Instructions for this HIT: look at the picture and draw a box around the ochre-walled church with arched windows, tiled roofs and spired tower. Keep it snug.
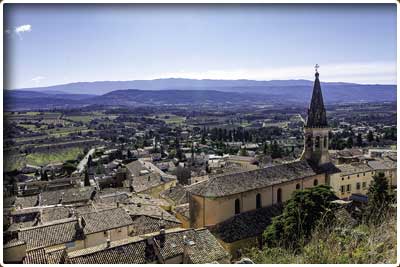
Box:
[188,65,339,256]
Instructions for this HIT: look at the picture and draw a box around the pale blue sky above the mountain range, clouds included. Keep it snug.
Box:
[4,4,397,89]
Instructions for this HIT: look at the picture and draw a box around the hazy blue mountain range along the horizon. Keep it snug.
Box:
[4,78,396,110]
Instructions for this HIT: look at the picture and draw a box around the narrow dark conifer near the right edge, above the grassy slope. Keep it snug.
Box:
[366,172,390,224]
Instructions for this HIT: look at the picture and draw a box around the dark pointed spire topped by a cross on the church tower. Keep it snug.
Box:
[306,64,328,128]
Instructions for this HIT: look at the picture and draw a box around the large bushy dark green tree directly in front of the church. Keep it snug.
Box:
[263,185,336,248]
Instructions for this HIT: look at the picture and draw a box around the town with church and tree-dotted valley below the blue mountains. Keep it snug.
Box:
[3,72,397,264]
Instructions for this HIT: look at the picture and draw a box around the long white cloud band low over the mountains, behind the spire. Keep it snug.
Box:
[152,62,397,84]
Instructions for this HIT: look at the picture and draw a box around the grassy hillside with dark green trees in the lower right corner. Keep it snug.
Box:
[246,174,397,264]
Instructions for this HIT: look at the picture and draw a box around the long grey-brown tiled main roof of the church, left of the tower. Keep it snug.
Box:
[190,160,317,197]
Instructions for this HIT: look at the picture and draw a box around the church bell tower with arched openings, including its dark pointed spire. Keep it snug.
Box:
[301,64,330,165]
